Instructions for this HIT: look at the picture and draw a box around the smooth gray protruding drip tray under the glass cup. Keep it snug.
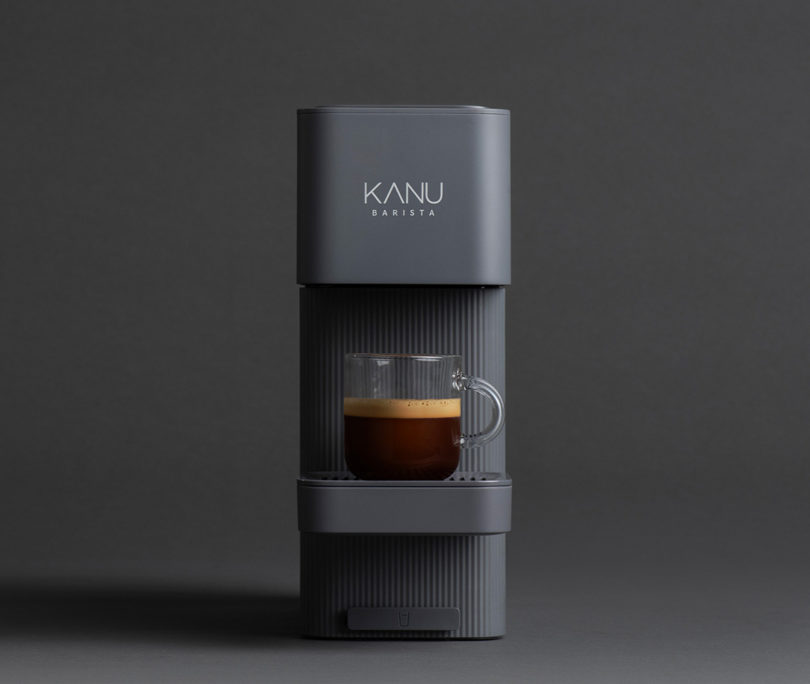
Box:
[298,472,512,534]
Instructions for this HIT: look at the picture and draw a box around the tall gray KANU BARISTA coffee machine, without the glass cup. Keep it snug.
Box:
[298,106,512,639]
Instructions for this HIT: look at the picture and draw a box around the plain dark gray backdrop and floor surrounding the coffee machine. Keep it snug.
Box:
[0,1,810,682]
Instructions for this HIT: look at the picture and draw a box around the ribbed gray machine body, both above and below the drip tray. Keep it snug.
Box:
[300,286,506,639]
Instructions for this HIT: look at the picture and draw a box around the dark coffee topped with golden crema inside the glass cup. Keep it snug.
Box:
[343,397,461,480]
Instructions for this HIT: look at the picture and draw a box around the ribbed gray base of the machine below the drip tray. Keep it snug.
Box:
[301,533,506,639]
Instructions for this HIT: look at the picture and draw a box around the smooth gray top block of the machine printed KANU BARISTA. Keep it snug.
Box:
[298,106,511,285]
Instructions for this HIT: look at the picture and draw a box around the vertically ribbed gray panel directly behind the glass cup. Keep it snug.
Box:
[300,287,506,473]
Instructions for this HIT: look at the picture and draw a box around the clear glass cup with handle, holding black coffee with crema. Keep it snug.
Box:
[343,354,504,480]
